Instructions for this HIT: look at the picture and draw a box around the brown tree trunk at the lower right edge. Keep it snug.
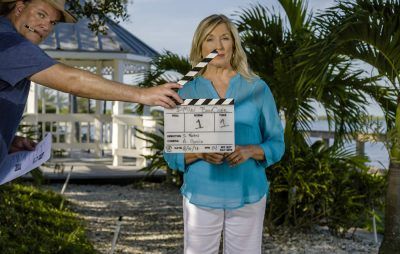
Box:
[379,161,400,254]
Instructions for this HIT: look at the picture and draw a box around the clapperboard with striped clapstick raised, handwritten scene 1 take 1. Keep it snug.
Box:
[164,50,235,153]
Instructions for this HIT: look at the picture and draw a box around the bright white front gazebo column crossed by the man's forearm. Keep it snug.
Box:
[112,60,124,166]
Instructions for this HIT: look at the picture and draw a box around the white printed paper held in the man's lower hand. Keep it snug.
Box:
[0,133,51,185]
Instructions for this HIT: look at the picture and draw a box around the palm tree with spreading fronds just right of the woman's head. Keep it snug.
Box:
[135,1,391,228]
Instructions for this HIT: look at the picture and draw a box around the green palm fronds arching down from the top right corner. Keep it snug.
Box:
[307,0,400,133]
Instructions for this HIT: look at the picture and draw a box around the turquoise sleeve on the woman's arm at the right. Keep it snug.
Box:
[255,80,285,167]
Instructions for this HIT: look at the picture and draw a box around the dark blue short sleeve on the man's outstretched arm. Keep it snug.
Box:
[0,33,57,86]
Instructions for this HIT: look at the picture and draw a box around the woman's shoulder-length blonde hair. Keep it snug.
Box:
[189,14,257,80]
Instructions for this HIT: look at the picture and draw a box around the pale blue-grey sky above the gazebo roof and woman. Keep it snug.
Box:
[120,0,382,116]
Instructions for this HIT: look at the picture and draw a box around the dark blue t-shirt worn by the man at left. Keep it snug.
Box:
[0,16,57,167]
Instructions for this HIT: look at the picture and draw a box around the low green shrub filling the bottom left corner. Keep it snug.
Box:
[0,184,95,254]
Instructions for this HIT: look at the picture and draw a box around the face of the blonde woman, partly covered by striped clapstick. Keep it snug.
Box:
[201,23,234,68]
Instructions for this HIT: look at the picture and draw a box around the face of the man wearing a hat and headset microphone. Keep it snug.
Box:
[12,0,61,44]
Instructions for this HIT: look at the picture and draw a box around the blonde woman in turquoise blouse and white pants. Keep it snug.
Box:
[164,15,284,254]
